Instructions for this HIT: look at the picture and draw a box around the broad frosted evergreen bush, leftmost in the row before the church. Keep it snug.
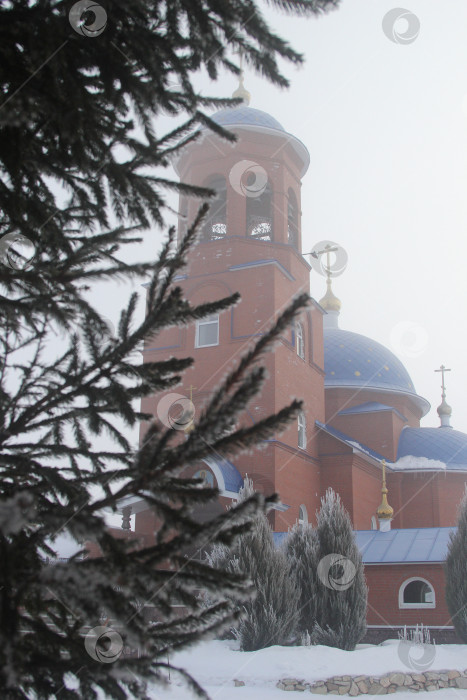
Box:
[208,479,300,651]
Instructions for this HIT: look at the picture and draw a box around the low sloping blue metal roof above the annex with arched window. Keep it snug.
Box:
[274,527,457,564]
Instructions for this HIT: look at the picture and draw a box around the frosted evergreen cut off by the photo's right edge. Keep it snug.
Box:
[444,490,467,644]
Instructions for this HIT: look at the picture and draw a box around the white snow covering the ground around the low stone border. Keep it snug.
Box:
[144,640,467,700]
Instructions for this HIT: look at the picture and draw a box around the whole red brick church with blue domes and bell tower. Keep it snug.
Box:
[117,80,467,642]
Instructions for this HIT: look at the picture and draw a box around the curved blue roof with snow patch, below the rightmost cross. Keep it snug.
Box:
[397,427,467,469]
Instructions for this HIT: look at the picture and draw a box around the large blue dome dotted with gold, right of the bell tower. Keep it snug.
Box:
[324,328,419,399]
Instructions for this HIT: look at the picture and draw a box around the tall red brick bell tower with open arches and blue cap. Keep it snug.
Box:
[143,85,324,531]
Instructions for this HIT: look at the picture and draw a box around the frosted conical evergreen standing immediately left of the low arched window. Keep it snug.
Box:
[312,489,367,650]
